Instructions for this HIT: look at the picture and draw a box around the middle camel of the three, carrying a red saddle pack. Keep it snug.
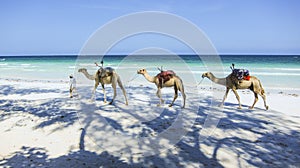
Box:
[137,69,186,108]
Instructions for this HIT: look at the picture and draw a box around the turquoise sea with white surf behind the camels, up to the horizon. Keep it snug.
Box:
[0,55,300,90]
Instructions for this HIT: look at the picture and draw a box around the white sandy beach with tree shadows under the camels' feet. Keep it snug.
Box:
[0,79,300,167]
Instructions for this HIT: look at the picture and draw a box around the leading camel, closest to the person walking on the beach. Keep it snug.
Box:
[78,67,128,105]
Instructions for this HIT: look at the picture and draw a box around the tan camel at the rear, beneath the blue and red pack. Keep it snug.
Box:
[202,72,269,110]
